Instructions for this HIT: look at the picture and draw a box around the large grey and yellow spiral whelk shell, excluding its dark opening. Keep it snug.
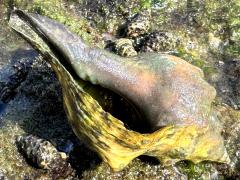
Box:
[10,11,229,170]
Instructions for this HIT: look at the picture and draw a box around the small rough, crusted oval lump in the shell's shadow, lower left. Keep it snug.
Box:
[16,135,72,178]
